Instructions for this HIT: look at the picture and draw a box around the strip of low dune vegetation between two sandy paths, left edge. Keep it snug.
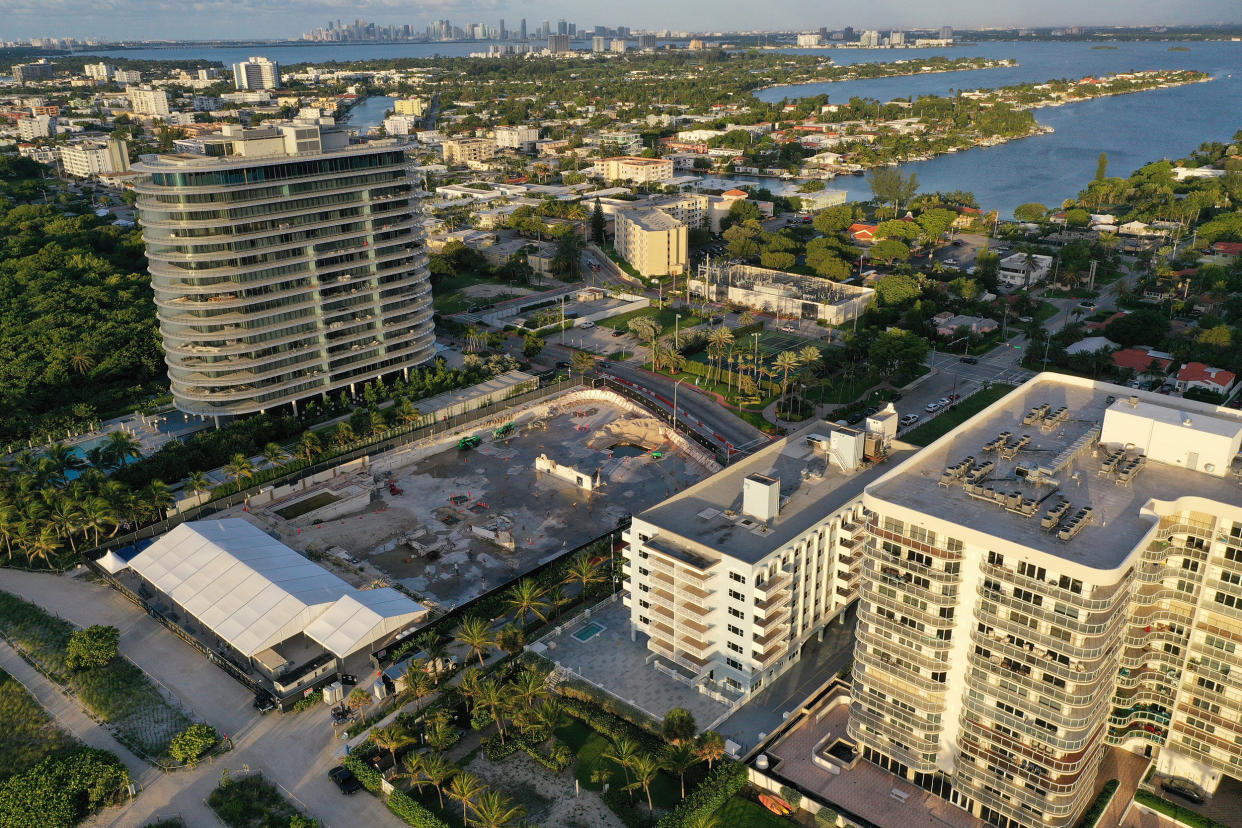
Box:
[0,591,191,765]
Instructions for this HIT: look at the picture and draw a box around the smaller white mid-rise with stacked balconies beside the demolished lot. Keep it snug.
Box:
[623,417,910,698]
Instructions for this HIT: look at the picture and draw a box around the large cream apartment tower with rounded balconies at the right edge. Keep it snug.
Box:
[850,374,1242,828]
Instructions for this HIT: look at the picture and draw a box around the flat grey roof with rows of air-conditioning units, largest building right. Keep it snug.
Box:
[867,374,1242,570]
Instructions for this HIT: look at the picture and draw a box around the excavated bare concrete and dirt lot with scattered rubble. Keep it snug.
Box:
[275,397,707,607]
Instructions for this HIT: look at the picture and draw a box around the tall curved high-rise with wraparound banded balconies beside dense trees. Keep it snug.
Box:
[134,122,435,418]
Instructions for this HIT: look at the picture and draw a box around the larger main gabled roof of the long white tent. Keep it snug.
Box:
[129,518,354,657]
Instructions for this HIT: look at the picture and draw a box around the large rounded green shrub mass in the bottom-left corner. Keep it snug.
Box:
[0,747,129,828]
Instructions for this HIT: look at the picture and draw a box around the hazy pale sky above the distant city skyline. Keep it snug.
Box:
[9,0,1242,40]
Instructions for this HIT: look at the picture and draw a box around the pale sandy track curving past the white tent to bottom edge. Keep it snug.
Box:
[0,570,405,828]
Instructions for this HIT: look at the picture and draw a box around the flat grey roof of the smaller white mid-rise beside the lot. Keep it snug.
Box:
[637,421,917,564]
